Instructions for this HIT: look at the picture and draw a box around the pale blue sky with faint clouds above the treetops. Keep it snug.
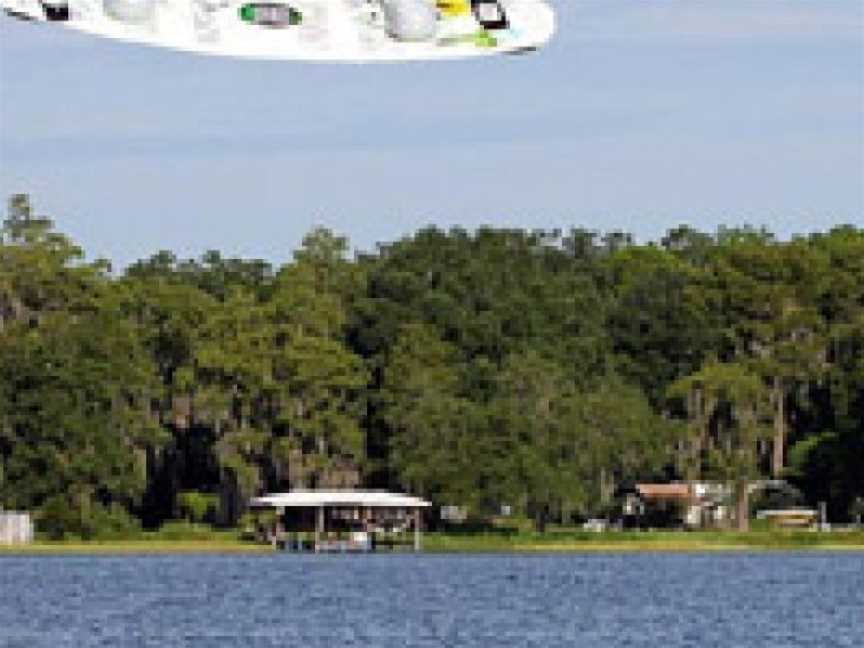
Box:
[0,0,864,267]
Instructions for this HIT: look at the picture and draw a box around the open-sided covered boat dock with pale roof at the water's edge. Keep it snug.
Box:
[249,490,431,553]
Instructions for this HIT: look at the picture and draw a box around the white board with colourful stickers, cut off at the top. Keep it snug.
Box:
[0,0,555,62]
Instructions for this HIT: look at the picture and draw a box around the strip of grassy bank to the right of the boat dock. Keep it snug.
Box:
[424,531,864,552]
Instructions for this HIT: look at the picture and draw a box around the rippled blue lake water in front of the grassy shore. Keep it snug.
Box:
[0,553,864,648]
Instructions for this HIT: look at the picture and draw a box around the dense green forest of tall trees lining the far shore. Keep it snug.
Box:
[0,195,864,537]
